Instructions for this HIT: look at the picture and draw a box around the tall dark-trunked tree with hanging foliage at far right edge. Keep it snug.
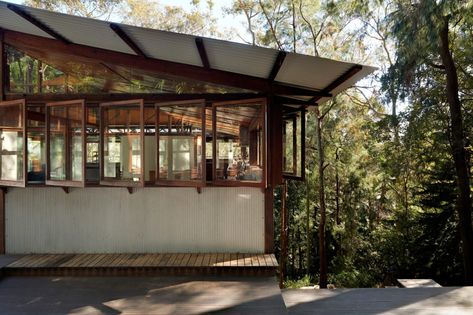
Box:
[392,0,473,284]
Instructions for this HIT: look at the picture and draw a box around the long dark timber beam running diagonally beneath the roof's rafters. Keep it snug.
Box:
[5,30,331,97]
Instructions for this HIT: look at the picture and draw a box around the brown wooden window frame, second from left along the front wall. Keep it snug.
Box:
[45,99,87,187]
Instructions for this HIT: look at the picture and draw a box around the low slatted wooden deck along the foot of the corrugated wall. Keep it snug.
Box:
[4,253,278,275]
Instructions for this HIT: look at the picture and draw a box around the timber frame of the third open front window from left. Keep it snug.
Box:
[99,99,145,187]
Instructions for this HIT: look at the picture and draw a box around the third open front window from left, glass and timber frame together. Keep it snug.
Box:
[100,100,144,187]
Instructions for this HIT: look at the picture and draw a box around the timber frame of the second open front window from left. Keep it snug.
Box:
[45,99,87,188]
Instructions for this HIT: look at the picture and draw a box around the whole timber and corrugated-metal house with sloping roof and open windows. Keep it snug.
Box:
[0,2,373,266]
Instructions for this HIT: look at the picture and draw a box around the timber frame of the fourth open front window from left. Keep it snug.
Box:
[155,99,206,187]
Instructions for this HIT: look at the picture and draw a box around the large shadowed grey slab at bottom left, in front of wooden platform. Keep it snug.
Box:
[0,276,286,315]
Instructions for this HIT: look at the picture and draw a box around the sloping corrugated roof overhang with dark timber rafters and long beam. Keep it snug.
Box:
[0,1,375,104]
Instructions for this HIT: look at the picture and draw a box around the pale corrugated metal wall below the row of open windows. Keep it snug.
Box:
[6,187,264,254]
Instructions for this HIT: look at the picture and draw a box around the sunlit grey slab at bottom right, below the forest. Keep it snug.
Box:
[282,287,473,315]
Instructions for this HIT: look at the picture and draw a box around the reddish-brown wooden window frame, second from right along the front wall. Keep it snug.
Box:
[155,99,207,187]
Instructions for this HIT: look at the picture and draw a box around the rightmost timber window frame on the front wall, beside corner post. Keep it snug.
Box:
[212,98,268,188]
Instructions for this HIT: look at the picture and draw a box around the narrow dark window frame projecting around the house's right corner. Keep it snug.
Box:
[281,107,306,181]
